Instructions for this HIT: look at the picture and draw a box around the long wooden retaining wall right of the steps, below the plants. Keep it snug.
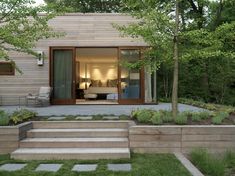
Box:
[129,125,235,153]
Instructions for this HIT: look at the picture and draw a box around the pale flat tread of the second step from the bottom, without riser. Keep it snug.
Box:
[20,138,128,142]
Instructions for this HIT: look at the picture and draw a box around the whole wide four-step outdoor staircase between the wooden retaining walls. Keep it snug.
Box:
[11,121,131,160]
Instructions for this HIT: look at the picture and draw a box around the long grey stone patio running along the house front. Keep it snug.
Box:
[0,103,206,116]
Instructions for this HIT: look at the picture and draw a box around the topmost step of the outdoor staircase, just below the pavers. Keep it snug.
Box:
[32,120,130,129]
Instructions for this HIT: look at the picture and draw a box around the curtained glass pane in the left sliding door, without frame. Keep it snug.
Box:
[53,50,73,99]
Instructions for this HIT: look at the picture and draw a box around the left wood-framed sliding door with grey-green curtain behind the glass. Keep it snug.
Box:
[51,48,75,104]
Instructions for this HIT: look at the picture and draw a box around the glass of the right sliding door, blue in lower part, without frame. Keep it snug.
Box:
[120,50,141,99]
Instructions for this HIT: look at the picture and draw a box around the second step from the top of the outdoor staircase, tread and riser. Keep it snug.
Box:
[27,128,128,138]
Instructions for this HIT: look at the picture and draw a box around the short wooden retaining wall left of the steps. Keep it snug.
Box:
[0,122,32,154]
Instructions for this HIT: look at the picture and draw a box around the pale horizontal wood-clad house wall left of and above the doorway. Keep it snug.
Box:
[0,13,146,105]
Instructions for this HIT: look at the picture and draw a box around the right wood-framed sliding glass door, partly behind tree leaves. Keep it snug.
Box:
[119,49,144,104]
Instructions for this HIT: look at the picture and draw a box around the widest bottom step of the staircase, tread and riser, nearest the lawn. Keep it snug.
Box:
[11,148,130,160]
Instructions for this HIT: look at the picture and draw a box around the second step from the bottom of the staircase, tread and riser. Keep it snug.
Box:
[20,138,129,148]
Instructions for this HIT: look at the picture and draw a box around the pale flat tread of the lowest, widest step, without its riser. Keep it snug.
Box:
[12,148,130,155]
